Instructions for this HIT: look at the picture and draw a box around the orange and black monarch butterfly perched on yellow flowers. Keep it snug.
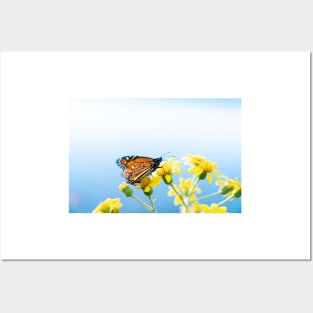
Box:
[116,155,162,185]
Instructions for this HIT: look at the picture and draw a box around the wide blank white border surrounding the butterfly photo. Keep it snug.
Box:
[1,52,311,260]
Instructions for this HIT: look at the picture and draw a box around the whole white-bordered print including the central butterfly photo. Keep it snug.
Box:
[1,52,311,260]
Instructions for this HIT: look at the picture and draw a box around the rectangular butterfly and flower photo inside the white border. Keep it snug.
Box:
[69,98,241,213]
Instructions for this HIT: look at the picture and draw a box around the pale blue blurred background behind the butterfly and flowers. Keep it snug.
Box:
[69,99,241,213]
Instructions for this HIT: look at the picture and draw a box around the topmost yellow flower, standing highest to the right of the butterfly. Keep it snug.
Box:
[184,154,217,183]
